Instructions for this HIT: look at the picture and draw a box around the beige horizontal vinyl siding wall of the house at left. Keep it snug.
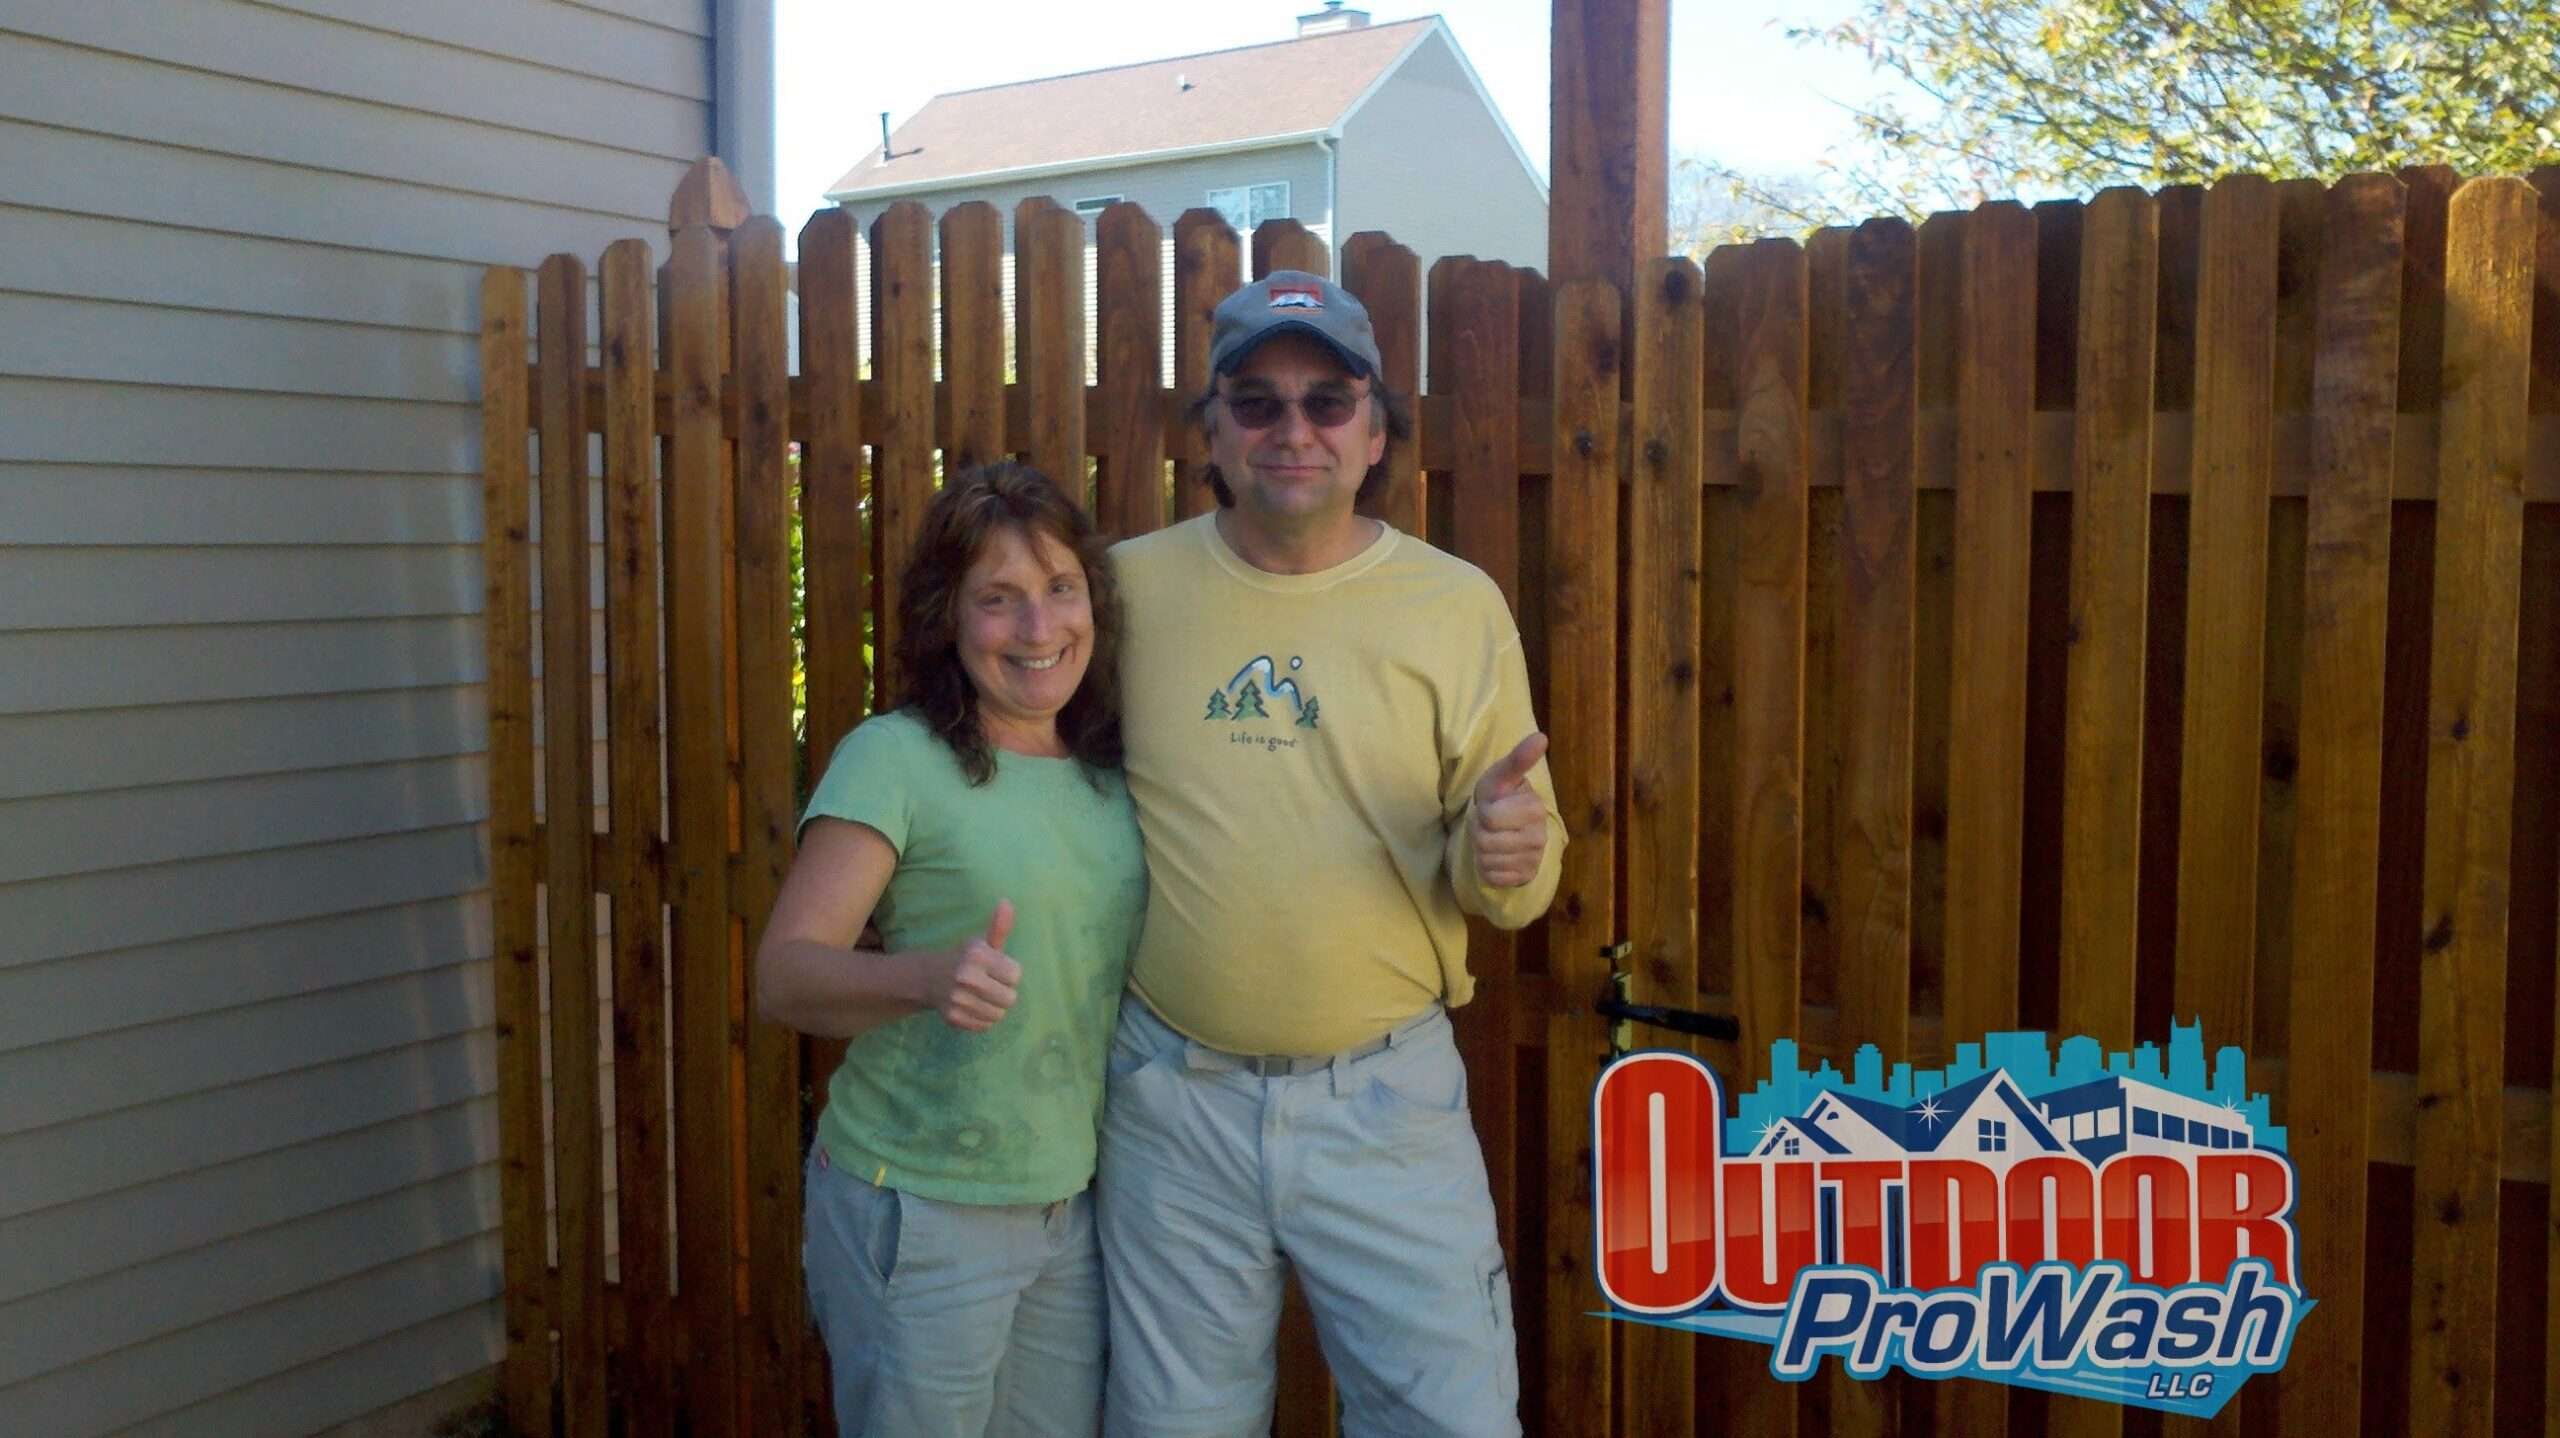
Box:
[0,0,712,1438]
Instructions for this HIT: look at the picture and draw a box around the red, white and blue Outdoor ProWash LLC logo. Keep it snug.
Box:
[1592,1026,2312,1418]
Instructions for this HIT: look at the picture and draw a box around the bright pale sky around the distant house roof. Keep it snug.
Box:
[776,0,1882,228]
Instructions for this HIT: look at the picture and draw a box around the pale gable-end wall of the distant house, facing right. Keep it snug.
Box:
[1336,28,1546,271]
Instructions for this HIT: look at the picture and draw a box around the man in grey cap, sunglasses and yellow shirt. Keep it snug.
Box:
[1098,271,1564,1438]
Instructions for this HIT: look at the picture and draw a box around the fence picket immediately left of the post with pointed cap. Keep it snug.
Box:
[596,241,676,1438]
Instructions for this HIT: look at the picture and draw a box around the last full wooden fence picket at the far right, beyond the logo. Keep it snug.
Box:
[2409,179,2540,1435]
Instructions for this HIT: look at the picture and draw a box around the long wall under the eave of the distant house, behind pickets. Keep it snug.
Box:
[845,141,1334,381]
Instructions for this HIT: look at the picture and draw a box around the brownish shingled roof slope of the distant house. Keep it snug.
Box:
[827,15,1439,200]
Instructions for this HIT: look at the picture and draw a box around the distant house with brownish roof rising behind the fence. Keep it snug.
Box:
[827,0,1546,363]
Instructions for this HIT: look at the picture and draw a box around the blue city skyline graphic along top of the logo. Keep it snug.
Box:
[1725,1021,2286,1157]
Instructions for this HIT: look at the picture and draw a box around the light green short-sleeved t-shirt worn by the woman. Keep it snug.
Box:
[801,711,1147,1203]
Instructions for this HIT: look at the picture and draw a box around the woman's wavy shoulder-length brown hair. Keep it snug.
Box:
[899,461,1121,786]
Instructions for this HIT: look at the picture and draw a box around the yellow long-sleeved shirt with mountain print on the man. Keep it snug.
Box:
[1111,514,1564,1054]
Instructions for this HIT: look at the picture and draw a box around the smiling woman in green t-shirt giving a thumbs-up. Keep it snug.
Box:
[755,463,1147,1438]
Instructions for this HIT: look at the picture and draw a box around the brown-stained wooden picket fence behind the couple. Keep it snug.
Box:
[481,169,2560,1438]
